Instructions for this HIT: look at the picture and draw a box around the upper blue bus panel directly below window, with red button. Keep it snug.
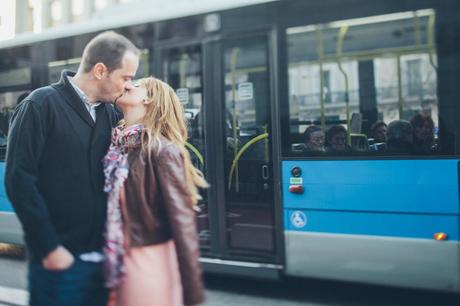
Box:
[282,160,459,214]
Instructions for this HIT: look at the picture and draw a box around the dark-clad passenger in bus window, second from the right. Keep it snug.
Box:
[387,120,413,154]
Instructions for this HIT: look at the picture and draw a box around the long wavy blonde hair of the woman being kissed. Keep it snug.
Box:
[139,77,208,206]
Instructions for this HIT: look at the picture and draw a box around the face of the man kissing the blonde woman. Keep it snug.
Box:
[99,51,139,102]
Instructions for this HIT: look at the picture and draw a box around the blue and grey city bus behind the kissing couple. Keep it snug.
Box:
[0,0,460,292]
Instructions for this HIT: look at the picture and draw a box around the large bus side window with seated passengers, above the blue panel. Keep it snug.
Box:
[283,10,453,156]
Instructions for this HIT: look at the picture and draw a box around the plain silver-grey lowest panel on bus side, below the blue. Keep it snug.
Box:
[285,231,460,292]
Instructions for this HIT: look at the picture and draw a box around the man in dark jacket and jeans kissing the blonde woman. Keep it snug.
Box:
[5,32,139,306]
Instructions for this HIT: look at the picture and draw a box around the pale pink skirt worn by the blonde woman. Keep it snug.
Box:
[109,240,183,306]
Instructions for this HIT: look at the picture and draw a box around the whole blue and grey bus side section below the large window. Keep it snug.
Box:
[282,160,460,291]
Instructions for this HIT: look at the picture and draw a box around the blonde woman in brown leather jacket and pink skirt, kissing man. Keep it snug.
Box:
[104,77,207,306]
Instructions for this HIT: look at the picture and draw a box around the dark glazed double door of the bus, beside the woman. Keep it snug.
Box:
[161,36,277,276]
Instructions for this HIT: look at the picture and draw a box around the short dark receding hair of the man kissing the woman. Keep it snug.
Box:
[80,31,140,73]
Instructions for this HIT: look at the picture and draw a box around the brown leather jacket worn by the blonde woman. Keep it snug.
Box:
[121,138,204,305]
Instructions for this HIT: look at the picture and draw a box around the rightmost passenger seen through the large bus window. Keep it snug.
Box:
[410,113,438,154]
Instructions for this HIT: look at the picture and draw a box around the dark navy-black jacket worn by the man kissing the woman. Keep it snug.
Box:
[5,71,119,260]
